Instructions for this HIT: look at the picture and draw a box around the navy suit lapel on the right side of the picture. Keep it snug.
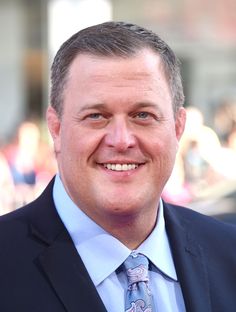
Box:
[164,204,211,312]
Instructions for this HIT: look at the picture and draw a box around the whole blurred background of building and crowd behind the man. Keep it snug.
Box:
[0,0,236,222]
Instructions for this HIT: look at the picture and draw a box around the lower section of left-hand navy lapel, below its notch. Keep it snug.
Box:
[39,231,106,312]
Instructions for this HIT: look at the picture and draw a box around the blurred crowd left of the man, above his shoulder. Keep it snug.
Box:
[0,121,56,214]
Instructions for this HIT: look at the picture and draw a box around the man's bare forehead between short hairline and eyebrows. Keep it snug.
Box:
[64,49,171,111]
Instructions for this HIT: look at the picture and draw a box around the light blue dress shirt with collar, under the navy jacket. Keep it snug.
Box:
[53,175,185,312]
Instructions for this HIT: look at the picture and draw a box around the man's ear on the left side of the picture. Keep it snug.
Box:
[46,106,61,155]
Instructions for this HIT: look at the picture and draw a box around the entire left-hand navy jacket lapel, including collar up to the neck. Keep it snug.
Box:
[27,181,106,312]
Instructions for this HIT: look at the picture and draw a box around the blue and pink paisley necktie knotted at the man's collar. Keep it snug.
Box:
[123,252,154,312]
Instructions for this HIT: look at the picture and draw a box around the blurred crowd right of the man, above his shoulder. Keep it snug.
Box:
[163,102,236,204]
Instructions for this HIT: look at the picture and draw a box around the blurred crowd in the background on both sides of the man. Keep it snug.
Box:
[0,103,236,214]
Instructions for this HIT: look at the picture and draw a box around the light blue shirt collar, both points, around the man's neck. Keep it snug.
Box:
[53,175,177,286]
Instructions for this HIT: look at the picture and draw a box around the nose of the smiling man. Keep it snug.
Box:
[105,118,136,152]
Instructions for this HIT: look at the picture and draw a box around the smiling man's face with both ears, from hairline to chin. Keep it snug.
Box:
[48,50,185,225]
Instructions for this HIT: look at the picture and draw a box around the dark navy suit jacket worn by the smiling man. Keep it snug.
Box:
[0,181,236,312]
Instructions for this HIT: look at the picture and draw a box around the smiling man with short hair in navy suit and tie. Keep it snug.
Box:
[0,22,236,312]
